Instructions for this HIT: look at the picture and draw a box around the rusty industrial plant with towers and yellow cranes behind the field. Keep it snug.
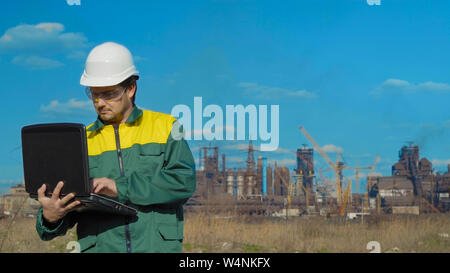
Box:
[185,127,450,218]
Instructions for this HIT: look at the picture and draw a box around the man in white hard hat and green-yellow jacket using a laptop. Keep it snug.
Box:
[36,42,196,252]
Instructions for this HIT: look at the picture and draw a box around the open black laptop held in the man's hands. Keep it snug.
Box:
[22,123,137,216]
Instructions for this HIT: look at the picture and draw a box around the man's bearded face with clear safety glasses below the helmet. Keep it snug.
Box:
[91,85,136,124]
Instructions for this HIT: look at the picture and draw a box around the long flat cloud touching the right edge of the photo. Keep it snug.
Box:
[371,79,450,96]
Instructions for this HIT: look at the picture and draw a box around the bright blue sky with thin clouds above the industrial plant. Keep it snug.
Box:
[0,0,450,192]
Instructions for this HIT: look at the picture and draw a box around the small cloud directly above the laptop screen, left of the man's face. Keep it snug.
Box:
[40,99,95,117]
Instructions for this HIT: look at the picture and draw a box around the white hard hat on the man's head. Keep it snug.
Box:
[80,42,139,86]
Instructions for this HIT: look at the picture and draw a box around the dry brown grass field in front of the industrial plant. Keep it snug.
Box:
[0,214,450,253]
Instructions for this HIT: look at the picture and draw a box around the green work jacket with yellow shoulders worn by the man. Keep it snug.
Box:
[36,106,196,252]
